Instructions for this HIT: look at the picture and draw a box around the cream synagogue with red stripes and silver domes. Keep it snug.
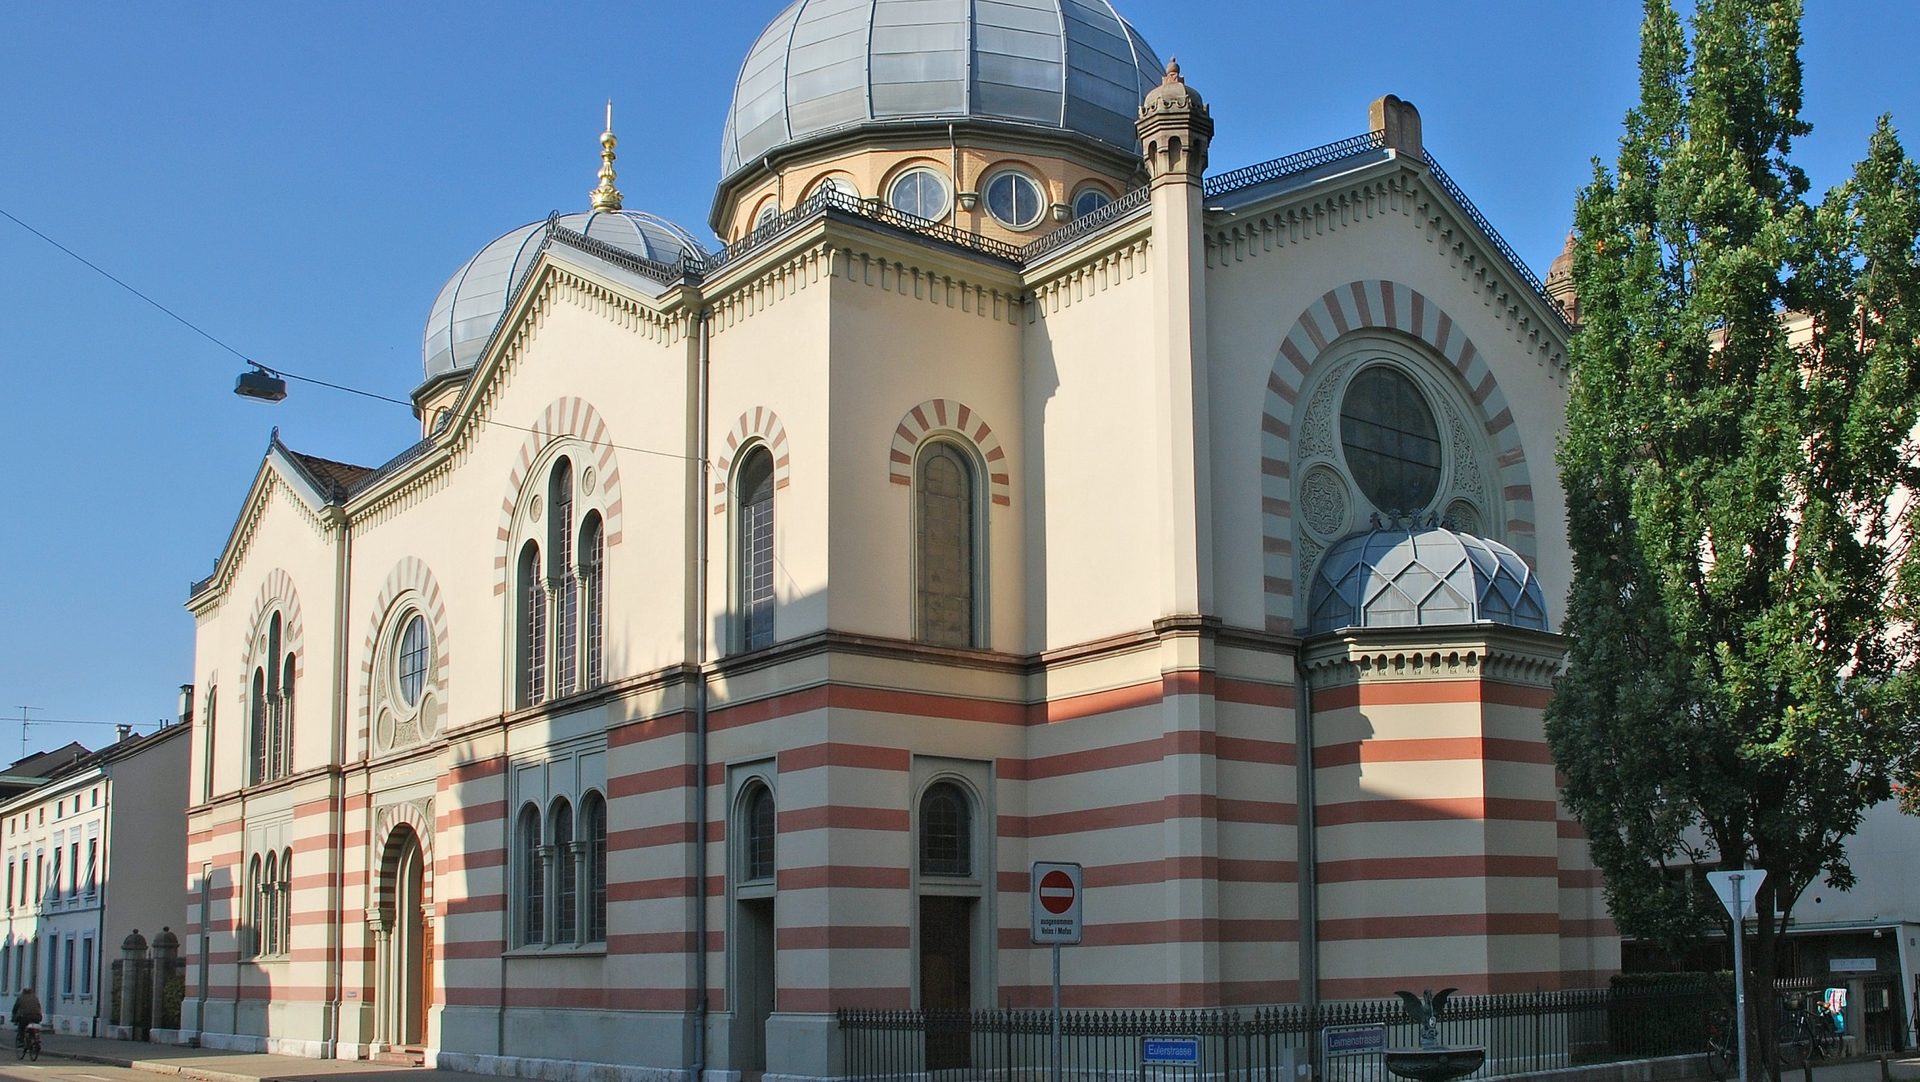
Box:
[182,0,1619,1078]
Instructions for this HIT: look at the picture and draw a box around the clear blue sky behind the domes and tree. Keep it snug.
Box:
[0,0,1920,762]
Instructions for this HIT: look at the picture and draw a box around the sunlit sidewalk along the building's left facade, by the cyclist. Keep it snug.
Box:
[40,1034,510,1082]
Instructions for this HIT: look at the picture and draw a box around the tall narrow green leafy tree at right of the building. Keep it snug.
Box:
[1548,0,1920,1066]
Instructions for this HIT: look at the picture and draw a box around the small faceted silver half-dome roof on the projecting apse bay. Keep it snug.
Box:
[1308,526,1548,635]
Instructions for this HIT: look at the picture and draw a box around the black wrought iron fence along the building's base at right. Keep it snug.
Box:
[837,982,1720,1082]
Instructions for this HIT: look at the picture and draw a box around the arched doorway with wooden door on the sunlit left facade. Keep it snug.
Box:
[374,823,434,1047]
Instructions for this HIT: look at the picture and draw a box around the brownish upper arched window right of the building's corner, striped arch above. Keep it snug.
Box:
[914,441,979,647]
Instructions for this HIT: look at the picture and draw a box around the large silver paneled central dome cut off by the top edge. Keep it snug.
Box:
[720,0,1162,176]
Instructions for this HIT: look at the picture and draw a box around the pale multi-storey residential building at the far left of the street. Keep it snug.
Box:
[0,725,190,1036]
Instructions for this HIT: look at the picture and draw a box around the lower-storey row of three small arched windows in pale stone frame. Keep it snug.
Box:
[515,790,607,946]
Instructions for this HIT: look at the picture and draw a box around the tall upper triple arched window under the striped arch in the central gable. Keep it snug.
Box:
[515,457,607,706]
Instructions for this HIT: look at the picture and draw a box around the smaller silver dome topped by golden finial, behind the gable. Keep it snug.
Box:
[420,211,703,380]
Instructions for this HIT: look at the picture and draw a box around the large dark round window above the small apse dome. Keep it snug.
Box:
[1340,365,1440,514]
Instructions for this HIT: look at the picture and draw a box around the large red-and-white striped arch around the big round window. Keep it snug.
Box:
[1260,278,1538,633]
